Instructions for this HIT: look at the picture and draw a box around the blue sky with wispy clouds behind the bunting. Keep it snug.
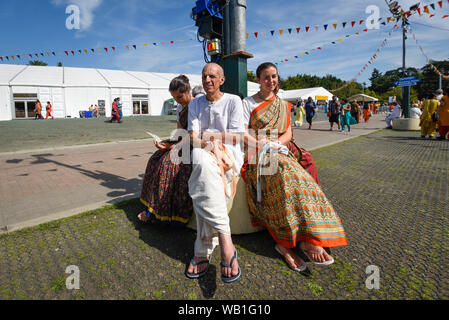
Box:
[0,0,449,83]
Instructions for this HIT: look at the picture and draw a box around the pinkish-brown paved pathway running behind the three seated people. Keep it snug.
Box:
[0,115,385,233]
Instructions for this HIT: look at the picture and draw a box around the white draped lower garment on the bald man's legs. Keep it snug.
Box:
[189,148,232,257]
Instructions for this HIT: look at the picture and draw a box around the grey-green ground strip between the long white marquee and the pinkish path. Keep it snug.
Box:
[0,116,176,152]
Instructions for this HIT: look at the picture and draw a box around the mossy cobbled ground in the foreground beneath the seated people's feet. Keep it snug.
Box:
[0,130,449,300]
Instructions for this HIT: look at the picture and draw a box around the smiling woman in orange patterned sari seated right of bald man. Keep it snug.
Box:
[242,63,348,271]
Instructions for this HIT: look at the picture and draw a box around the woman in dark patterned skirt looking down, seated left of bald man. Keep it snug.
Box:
[138,75,193,226]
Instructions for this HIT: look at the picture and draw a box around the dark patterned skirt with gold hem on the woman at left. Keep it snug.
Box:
[140,150,193,226]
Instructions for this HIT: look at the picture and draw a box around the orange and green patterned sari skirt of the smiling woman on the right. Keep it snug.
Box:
[246,153,348,248]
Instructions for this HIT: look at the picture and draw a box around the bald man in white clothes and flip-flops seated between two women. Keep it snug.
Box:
[186,63,245,283]
